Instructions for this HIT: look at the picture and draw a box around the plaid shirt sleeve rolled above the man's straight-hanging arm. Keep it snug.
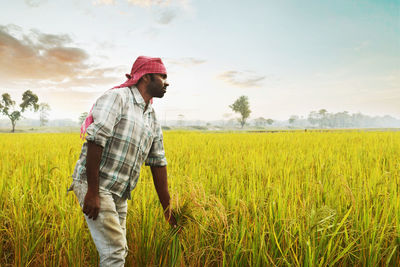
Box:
[86,90,123,147]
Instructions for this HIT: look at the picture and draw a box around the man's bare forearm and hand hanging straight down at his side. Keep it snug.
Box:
[83,141,103,220]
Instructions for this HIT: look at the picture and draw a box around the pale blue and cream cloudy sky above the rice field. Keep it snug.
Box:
[0,0,400,120]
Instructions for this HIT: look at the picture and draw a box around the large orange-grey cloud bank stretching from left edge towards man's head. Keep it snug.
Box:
[0,25,119,87]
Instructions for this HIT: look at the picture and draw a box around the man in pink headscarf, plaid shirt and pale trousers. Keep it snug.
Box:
[69,56,176,266]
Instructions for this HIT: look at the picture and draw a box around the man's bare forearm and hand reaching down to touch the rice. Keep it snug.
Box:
[150,166,176,227]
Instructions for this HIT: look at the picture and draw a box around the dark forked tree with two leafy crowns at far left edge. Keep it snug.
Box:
[0,90,39,132]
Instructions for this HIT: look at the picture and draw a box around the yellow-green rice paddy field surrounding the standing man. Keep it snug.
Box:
[0,131,400,266]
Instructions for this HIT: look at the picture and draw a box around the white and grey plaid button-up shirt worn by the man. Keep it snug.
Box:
[72,87,167,197]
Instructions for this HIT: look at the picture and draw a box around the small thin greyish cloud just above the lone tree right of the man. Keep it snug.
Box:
[217,70,266,88]
